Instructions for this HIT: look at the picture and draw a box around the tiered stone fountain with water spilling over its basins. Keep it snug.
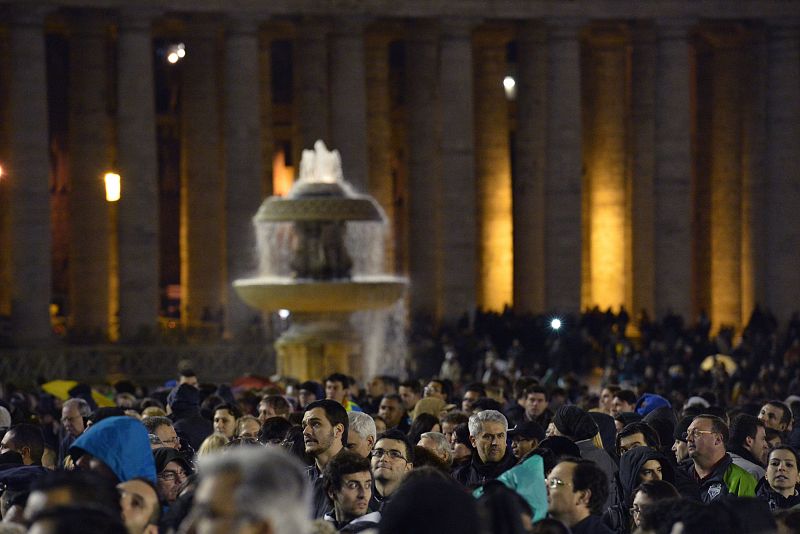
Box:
[233,141,408,380]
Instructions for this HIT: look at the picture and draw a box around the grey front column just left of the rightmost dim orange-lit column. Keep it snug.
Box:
[654,19,692,317]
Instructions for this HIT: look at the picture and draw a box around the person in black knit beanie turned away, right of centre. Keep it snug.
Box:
[553,405,617,507]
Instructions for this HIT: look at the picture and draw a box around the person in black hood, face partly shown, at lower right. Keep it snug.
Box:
[603,446,675,534]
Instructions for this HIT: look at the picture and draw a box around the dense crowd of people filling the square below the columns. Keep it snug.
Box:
[0,310,800,534]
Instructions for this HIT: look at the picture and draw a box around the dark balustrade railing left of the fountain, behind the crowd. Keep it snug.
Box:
[0,343,275,386]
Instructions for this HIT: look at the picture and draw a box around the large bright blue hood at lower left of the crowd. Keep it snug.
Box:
[69,416,156,484]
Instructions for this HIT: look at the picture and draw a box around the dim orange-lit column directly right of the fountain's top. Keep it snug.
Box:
[365,31,396,271]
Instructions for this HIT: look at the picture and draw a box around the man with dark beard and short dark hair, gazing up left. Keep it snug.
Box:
[302,399,350,519]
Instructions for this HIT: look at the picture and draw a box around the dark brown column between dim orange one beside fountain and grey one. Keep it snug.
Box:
[405,21,444,318]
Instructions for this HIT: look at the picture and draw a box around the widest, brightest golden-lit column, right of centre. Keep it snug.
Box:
[584,28,630,309]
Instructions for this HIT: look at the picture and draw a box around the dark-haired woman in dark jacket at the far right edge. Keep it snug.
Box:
[756,445,800,512]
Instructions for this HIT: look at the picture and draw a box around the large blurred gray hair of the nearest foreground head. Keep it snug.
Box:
[199,447,311,534]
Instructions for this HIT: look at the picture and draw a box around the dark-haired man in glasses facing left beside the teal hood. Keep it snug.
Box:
[547,459,612,534]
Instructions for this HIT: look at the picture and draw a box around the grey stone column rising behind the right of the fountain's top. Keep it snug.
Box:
[328,17,369,193]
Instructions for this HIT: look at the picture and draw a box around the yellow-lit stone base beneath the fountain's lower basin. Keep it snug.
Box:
[275,314,361,381]
